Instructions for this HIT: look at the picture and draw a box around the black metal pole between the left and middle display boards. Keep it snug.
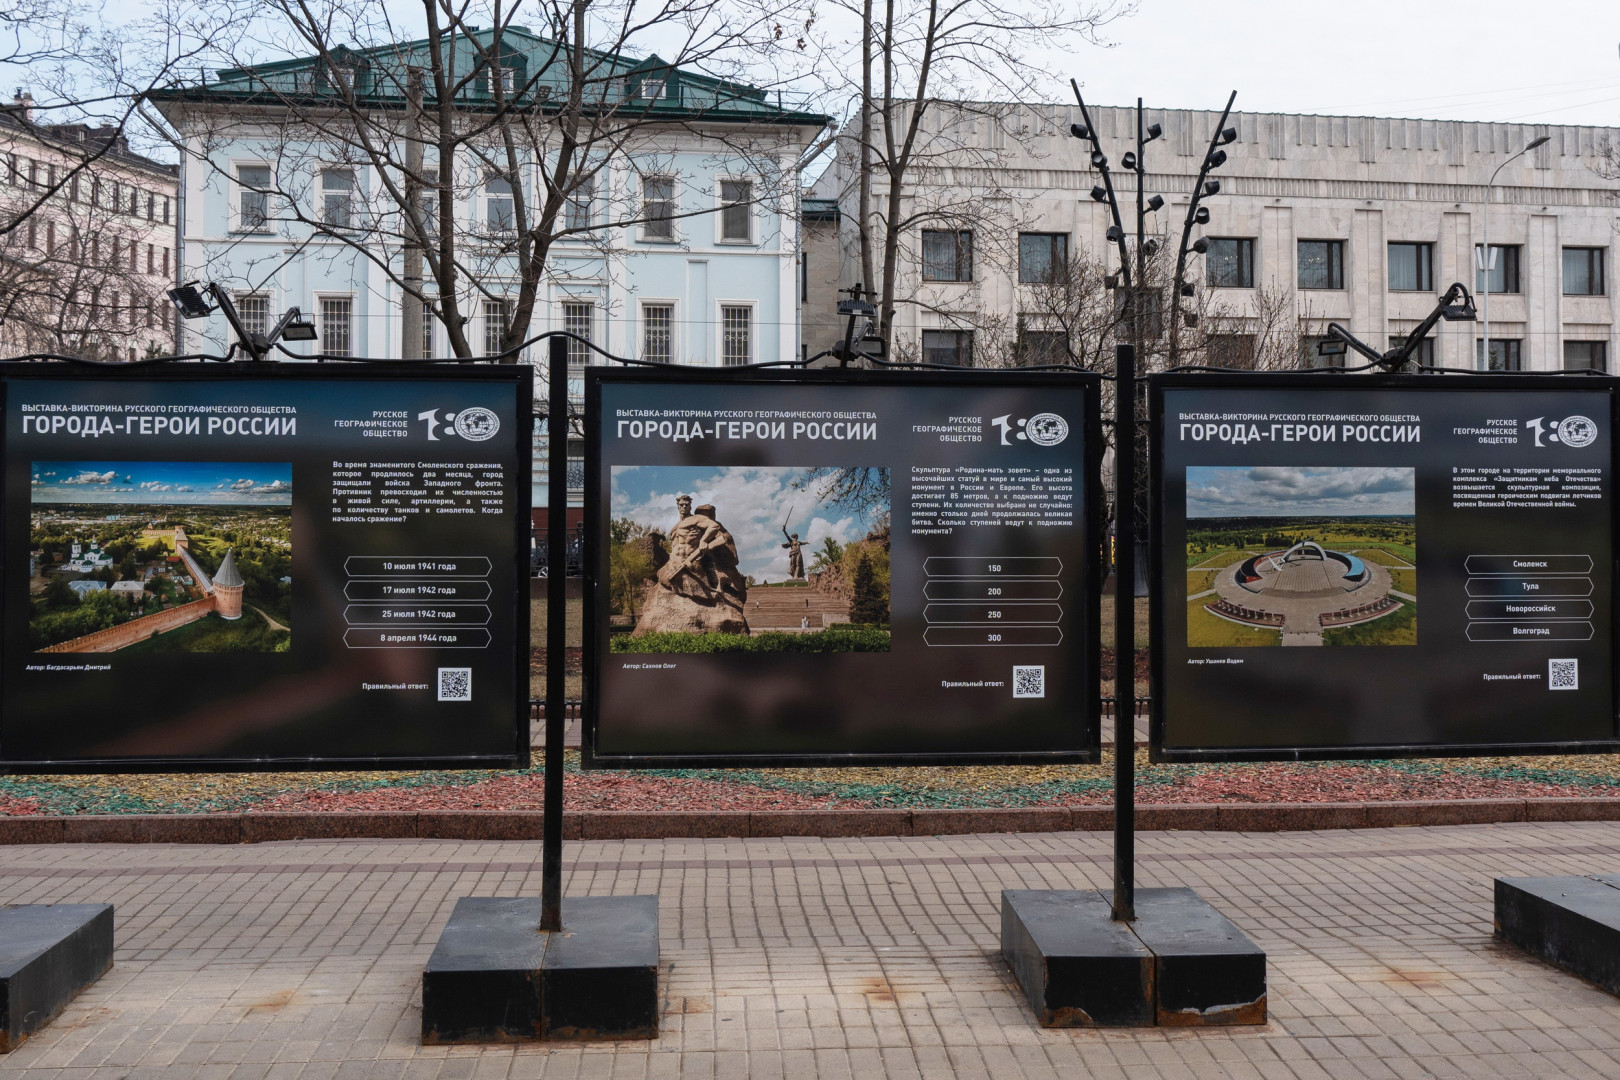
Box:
[539,335,569,931]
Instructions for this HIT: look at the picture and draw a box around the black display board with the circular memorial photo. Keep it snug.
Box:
[1150,374,1615,761]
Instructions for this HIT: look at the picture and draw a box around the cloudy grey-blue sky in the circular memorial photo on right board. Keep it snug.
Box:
[1187,465,1414,518]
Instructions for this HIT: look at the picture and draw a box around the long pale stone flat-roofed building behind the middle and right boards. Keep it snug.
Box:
[807,105,1620,371]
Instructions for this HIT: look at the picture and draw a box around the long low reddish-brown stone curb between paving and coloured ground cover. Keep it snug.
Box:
[0,798,1620,845]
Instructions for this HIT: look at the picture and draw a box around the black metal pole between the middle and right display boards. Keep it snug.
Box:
[1114,345,1136,923]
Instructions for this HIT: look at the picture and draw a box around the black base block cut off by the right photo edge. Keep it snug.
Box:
[1495,874,1620,994]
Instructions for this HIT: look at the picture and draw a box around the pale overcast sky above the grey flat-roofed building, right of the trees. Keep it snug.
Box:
[1048,0,1620,126]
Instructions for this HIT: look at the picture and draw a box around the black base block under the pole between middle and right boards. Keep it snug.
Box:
[1001,889,1265,1028]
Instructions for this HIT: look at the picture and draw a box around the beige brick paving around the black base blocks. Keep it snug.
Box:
[0,821,1620,1080]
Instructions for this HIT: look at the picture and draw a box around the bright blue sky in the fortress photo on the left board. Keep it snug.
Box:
[34,461,293,507]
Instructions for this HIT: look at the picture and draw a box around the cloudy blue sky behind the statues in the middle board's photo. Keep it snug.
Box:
[609,465,872,581]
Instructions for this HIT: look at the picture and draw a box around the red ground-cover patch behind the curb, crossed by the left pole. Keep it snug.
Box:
[249,772,868,813]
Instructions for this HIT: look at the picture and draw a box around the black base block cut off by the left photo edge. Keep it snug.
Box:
[0,904,112,1054]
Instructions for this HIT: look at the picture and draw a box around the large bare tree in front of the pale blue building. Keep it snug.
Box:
[154,0,821,361]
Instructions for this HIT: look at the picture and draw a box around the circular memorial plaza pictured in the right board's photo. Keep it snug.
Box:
[1204,539,1405,644]
